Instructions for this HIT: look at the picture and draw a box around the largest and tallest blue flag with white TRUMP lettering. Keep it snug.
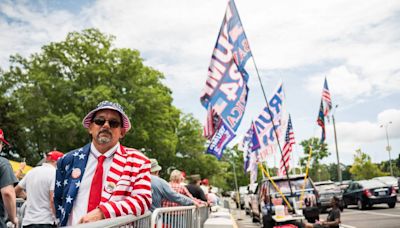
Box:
[200,0,251,157]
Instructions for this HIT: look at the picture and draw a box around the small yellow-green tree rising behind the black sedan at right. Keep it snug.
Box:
[350,149,388,180]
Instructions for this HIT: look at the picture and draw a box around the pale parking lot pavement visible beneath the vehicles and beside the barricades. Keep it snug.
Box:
[232,203,400,228]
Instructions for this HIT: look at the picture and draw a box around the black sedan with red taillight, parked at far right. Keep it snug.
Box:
[343,179,396,210]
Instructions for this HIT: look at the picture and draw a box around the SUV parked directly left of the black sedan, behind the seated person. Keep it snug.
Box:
[314,181,343,212]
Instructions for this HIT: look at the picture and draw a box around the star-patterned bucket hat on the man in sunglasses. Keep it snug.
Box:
[82,101,131,131]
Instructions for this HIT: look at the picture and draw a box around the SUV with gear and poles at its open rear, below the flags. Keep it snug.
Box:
[251,175,319,227]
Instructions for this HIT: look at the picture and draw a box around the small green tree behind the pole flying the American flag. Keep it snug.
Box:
[300,138,330,180]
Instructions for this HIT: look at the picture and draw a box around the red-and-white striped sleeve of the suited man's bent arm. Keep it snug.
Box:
[99,151,151,218]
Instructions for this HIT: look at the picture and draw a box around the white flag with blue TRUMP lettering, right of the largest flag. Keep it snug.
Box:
[254,83,286,161]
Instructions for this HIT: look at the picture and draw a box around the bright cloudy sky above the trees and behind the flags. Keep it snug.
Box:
[0,0,400,167]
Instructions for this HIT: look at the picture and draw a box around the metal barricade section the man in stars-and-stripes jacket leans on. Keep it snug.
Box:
[74,211,151,228]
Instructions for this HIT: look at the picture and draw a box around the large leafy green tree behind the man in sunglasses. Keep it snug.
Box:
[0,29,180,164]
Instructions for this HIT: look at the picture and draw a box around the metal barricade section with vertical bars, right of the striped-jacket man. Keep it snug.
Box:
[151,206,208,228]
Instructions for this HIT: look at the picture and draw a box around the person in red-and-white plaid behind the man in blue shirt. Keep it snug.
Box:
[162,170,206,207]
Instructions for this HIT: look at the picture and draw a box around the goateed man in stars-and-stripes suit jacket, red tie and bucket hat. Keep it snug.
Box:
[54,101,151,226]
